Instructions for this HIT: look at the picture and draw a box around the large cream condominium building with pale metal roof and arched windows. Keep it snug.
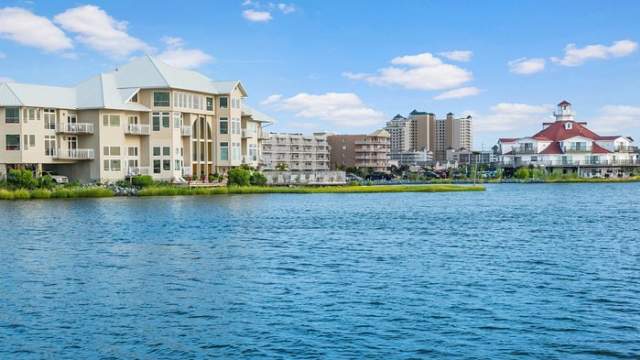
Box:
[0,56,270,182]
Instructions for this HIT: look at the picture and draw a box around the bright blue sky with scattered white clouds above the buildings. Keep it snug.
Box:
[0,0,640,149]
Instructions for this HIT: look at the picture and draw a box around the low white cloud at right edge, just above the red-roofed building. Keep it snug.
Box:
[589,105,640,136]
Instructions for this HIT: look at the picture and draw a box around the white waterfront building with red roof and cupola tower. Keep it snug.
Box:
[498,101,640,176]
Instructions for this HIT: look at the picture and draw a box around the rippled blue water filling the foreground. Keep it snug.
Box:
[0,184,640,359]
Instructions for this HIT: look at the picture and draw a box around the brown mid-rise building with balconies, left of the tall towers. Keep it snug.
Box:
[327,130,391,171]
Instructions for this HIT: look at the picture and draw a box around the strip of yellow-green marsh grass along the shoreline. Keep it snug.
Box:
[0,184,485,200]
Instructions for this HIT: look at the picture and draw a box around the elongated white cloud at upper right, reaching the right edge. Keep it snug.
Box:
[551,40,638,66]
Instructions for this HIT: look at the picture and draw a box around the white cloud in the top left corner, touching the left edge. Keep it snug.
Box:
[0,7,73,52]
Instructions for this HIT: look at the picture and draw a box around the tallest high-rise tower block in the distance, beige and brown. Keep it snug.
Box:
[385,110,472,165]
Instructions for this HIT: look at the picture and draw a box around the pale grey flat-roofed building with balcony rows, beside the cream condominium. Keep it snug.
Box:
[262,133,329,171]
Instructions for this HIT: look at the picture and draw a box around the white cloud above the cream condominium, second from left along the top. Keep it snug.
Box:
[54,5,151,58]
